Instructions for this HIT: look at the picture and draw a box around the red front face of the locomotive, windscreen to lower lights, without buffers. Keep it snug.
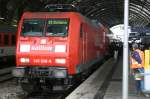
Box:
[16,19,69,77]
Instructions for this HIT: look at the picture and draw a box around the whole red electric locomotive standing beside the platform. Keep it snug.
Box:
[13,12,107,91]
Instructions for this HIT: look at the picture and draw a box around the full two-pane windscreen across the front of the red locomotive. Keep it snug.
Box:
[21,19,69,36]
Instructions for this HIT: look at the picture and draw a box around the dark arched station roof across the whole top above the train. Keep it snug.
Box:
[0,0,150,27]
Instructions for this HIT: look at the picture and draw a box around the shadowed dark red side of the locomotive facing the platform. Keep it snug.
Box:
[76,19,106,72]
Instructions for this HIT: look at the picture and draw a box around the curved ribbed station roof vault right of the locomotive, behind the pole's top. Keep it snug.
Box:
[68,0,150,27]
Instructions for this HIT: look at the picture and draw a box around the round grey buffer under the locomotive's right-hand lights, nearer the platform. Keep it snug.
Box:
[53,69,67,78]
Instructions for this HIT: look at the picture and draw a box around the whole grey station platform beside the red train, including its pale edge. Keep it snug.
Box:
[65,57,149,99]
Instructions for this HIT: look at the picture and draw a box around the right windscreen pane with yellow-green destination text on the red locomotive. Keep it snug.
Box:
[46,19,69,36]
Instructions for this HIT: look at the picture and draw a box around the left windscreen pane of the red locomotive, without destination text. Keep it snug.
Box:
[22,19,44,36]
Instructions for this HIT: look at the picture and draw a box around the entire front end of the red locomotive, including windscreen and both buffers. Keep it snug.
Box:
[13,12,76,91]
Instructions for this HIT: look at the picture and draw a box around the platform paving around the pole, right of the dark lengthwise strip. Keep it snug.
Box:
[103,58,149,99]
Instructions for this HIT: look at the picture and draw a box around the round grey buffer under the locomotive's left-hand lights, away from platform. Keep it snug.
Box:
[12,68,25,77]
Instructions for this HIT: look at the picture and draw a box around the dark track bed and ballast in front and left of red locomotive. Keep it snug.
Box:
[0,67,79,99]
